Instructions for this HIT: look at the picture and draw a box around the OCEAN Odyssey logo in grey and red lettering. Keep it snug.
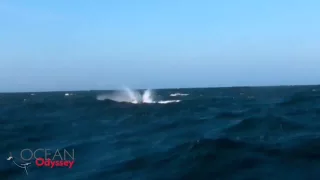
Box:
[7,148,75,175]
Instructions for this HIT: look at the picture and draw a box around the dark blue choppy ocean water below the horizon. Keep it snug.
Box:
[0,86,320,180]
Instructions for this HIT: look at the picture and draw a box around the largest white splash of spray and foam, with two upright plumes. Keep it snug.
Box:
[97,87,180,104]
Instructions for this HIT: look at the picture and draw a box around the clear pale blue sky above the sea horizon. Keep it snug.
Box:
[0,0,320,91]
